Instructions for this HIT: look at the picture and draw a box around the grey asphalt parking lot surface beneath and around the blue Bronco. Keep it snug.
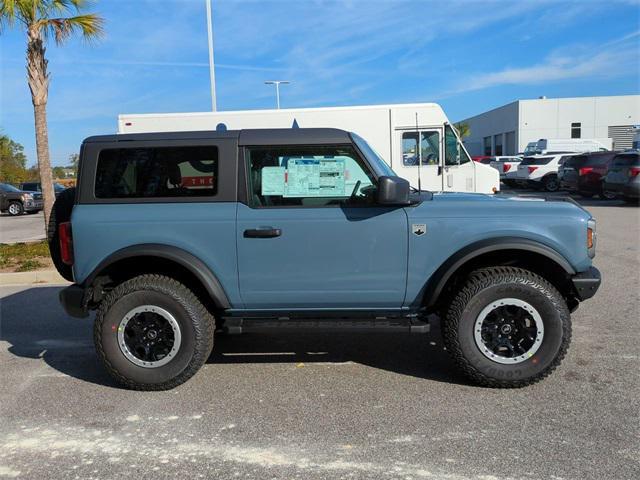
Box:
[0,197,640,480]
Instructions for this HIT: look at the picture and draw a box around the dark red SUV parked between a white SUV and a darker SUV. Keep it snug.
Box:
[558,152,616,199]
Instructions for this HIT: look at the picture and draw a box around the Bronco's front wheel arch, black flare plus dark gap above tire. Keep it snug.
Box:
[422,237,576,310]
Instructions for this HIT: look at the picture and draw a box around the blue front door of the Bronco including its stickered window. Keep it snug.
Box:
[237,145,408,310]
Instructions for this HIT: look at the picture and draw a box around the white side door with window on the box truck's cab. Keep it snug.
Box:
[393,128,442,192]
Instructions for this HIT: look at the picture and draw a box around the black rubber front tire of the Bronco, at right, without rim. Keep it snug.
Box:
[442,267,571,388]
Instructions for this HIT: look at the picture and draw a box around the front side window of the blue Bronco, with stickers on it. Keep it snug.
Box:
[247,145,376,207]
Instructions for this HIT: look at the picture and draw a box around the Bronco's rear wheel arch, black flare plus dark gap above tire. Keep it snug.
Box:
[82,243,231,309]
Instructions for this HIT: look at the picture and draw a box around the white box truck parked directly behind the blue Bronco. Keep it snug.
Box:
[118,103,500,193]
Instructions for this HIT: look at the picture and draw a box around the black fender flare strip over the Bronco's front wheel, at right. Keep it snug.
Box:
[420,237,576,308]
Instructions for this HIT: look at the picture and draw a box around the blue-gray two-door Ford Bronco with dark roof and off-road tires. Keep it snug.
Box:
[48,129,600,390]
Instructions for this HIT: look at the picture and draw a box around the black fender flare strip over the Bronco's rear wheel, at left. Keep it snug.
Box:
[83,243,231,309]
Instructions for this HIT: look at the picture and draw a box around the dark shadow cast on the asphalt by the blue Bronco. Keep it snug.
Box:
[0,286,467,388]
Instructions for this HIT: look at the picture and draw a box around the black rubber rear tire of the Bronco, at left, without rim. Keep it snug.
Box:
[93,275,215,390]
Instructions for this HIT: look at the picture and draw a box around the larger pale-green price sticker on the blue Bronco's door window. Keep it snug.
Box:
[284,158,347,198]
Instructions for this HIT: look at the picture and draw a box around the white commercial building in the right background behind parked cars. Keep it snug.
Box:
[463,95,640,155]
